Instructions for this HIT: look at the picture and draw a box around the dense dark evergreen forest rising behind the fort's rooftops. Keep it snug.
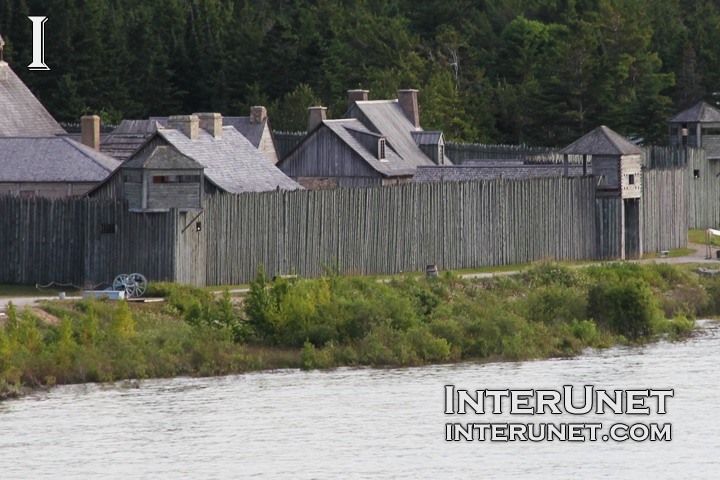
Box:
[0,0,720,146]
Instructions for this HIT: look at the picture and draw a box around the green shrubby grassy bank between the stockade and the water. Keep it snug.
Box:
[0,262,720,400]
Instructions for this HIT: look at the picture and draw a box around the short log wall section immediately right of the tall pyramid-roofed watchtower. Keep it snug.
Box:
[641,167,693,252]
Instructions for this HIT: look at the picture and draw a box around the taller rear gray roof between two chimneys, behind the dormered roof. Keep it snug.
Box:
[345,99,435,166]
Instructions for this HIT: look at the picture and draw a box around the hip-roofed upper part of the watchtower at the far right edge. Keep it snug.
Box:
[668,102,720,160]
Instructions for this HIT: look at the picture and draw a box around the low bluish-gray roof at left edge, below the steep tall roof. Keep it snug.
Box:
[0,137,120,182]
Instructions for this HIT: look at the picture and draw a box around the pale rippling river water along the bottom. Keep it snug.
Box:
[0,322,720,480]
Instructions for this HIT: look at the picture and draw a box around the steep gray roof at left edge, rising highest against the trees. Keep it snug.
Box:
[0,62,65,137]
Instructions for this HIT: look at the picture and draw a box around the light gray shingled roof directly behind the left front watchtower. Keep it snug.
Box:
[157,127,303,193]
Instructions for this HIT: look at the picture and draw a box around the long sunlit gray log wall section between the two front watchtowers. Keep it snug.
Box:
[201,177,595,285]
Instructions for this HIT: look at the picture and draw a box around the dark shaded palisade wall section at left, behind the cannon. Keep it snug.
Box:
[0,197,177,288]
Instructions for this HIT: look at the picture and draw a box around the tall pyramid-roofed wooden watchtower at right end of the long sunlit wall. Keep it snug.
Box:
[560,126,643,259]
